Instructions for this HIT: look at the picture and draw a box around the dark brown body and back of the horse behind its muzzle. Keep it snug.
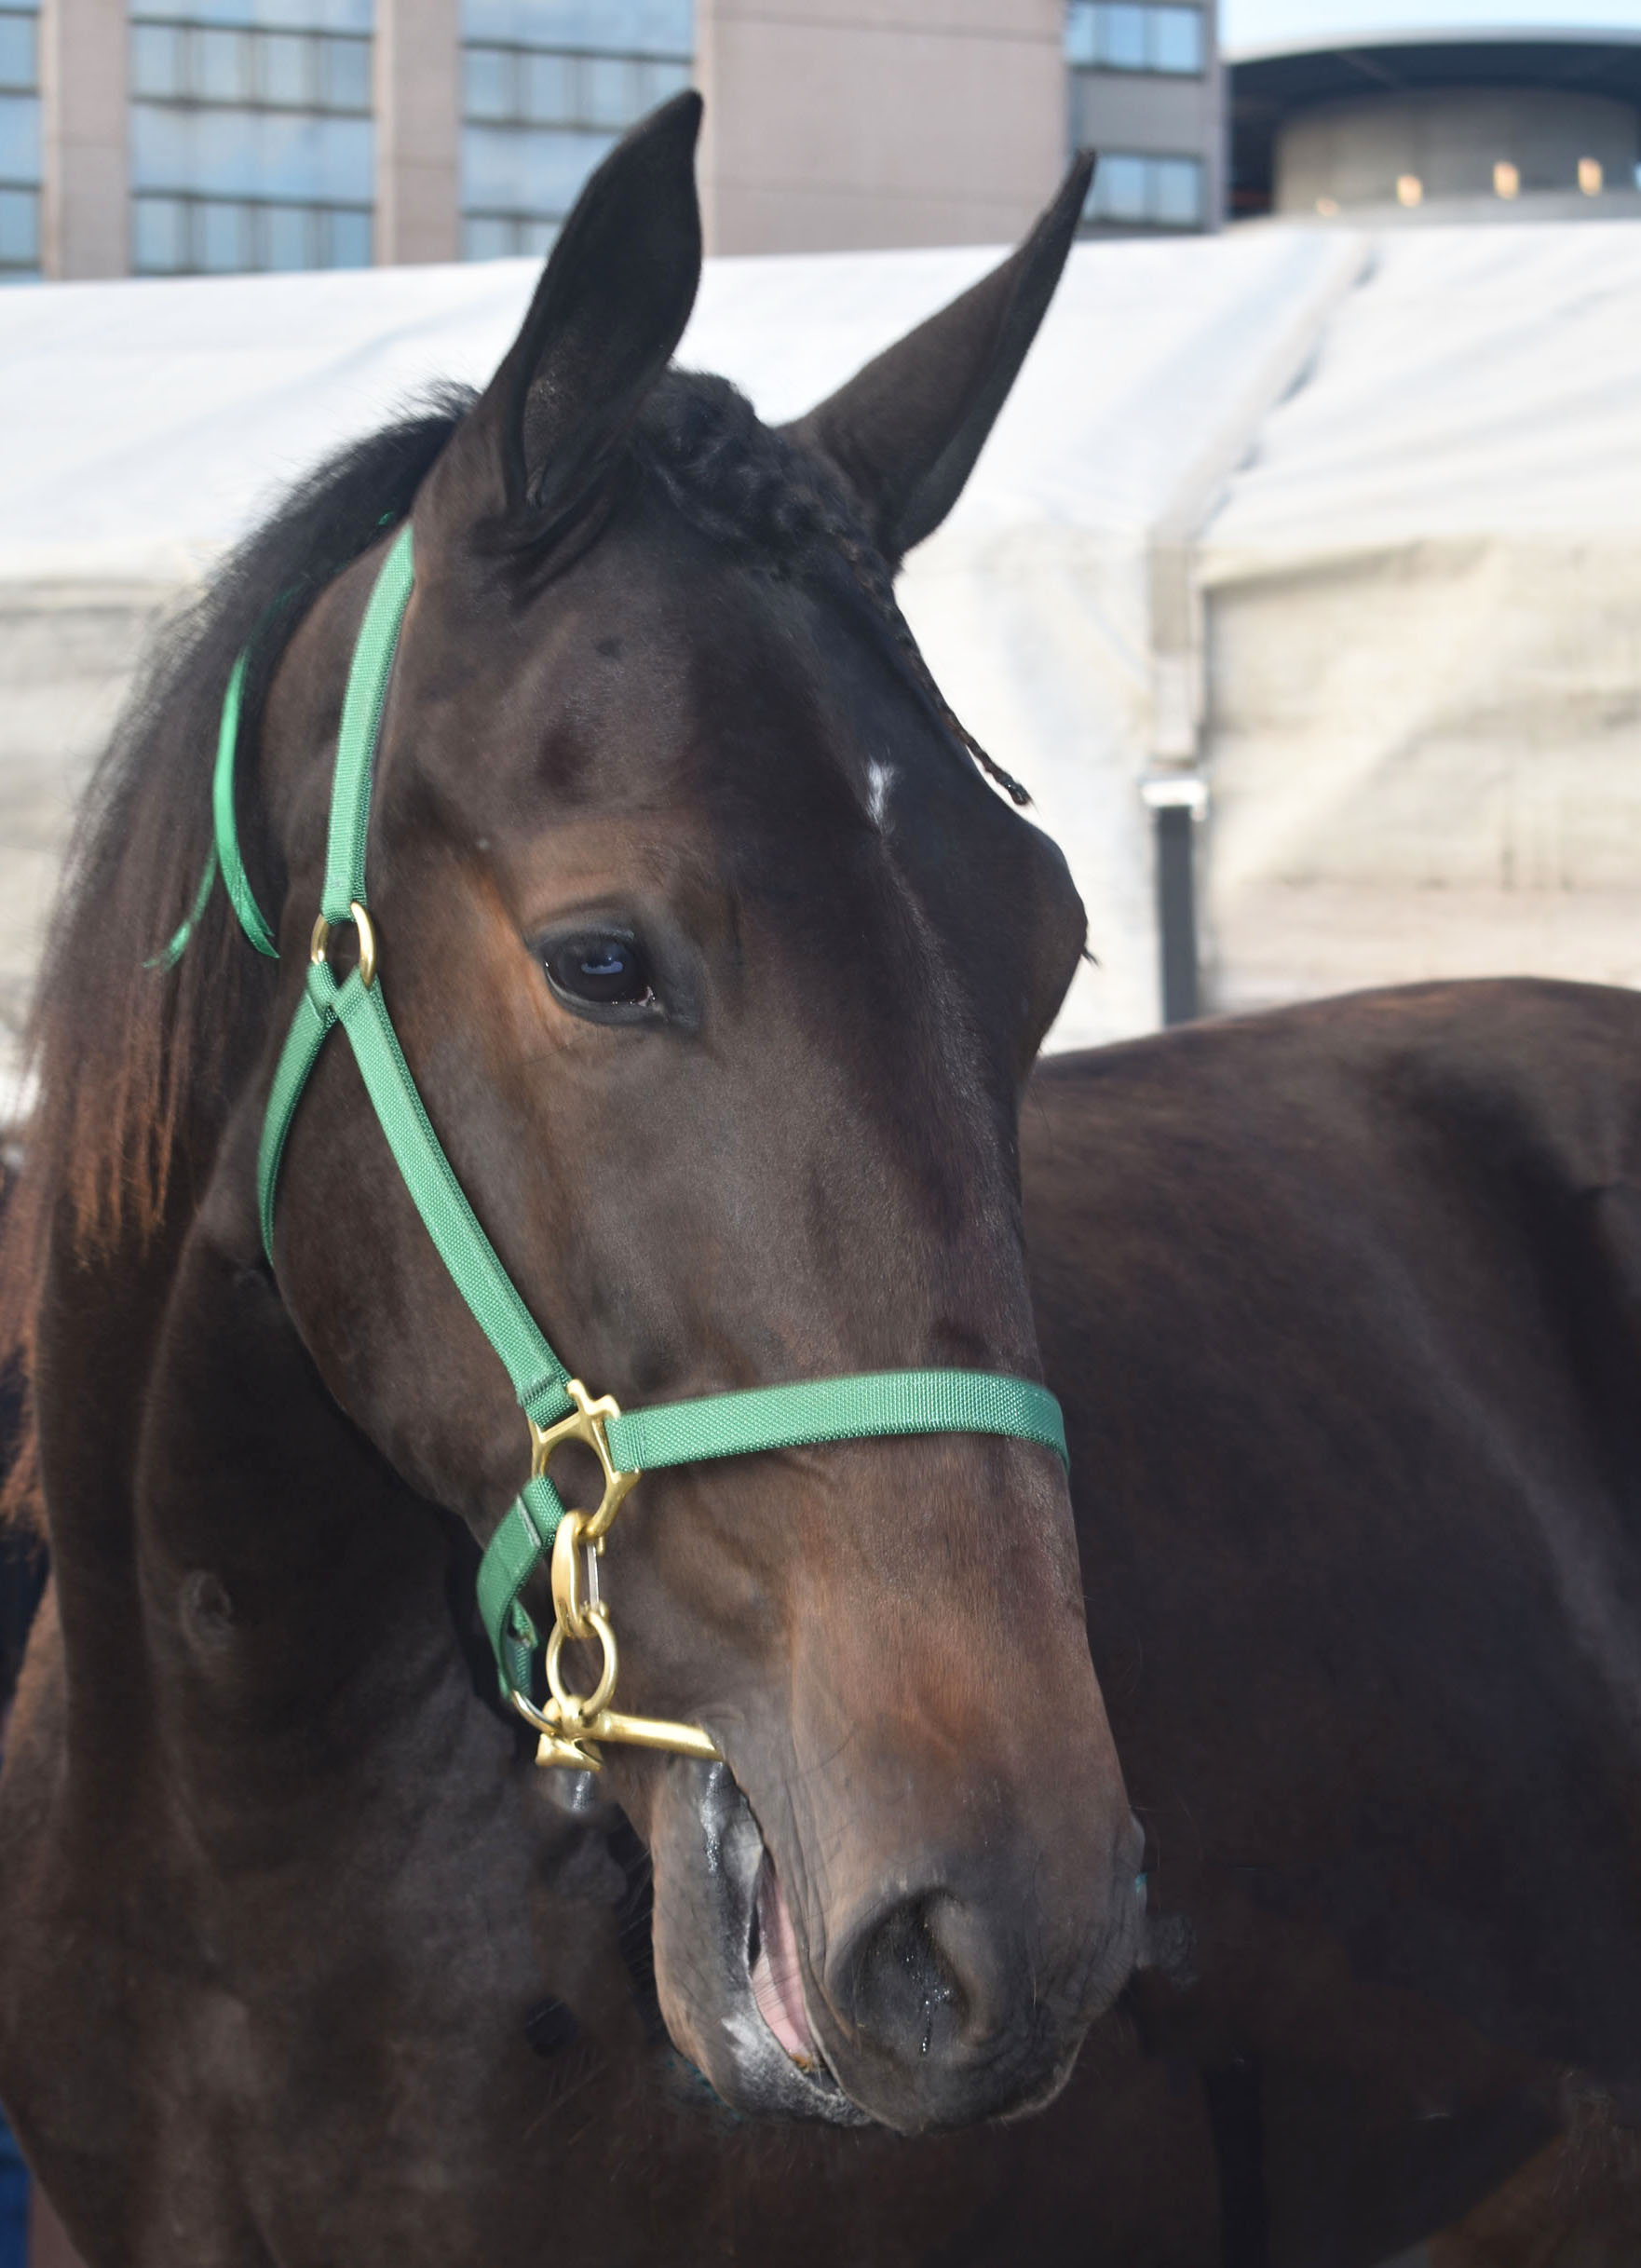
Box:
[1023,980,1641,2268]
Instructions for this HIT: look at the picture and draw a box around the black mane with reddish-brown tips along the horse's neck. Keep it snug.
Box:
[0,390,469,1506]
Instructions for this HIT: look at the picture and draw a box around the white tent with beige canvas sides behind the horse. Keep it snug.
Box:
[0,223,1641,1111]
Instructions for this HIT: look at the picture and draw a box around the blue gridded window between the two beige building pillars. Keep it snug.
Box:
[131,0,374,275]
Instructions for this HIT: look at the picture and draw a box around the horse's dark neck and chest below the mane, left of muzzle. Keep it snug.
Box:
[14,1107,648,2268]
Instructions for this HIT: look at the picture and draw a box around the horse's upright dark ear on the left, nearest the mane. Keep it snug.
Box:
[426,93,700,544]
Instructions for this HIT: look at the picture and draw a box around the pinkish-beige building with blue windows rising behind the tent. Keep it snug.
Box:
[0,0,1224,279]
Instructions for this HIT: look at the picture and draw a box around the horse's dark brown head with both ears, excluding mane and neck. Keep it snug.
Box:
[201,95,1138,2129]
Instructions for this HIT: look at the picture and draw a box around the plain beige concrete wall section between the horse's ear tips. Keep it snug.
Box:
[696,0,1065,251]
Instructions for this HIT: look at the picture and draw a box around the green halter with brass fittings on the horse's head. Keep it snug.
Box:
[176,522,1065,1769]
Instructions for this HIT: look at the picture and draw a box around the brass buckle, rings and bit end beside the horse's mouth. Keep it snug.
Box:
[512,1378,718,1772]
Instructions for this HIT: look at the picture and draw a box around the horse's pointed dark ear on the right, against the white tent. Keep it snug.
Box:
[784,152,1094,564]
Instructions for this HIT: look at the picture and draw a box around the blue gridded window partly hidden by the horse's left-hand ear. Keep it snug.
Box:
[462,0,694,261]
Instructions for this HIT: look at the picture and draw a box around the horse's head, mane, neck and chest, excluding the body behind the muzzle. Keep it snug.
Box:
[0,95,1143,2261]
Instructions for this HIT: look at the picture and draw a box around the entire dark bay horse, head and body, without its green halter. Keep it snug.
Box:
[0,79,1641,2268]
